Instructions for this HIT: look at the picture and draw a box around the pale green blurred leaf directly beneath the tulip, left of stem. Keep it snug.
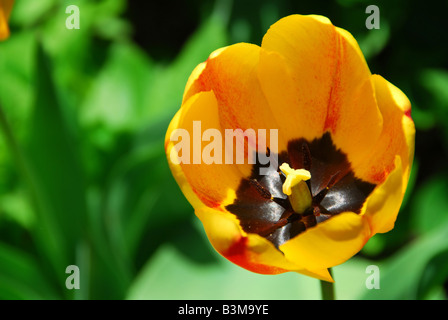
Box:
[127,245,320,300]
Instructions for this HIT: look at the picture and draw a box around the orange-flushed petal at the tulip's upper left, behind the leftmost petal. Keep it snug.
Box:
[180,43,286,152]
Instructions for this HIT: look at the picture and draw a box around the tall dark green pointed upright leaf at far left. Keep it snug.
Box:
[25,42,87,280]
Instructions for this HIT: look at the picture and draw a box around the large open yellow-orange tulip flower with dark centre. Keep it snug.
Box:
[165,15,415,282]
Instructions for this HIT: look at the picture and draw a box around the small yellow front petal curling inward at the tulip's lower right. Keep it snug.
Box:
[280,212,370,270]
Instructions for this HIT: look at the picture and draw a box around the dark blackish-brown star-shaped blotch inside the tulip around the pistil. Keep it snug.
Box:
[226,132,376,247]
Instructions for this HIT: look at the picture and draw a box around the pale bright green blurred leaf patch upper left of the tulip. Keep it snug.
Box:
[81,43,152,133]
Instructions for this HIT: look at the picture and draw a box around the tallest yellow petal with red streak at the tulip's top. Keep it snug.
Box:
[259,15,382,165]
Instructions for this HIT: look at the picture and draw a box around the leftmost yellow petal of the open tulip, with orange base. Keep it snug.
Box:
[165,91,243,208]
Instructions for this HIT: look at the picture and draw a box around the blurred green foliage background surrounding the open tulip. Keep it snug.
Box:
[0,0,448,299]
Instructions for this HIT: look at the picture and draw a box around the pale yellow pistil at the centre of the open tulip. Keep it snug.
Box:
[280,163,312,213]
